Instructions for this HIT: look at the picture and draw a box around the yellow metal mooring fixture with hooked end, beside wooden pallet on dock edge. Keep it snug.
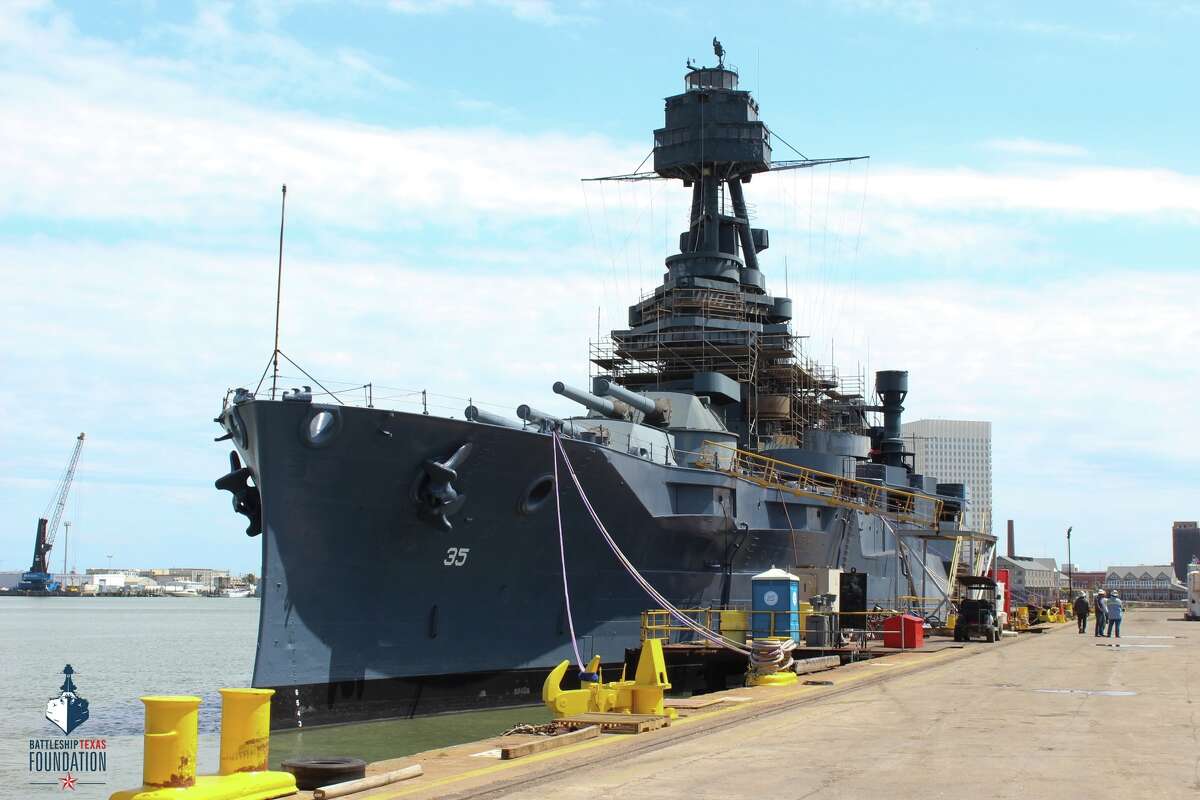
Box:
[541,639,676,718]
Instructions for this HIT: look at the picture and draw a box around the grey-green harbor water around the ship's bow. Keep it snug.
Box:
[0,597,550,800]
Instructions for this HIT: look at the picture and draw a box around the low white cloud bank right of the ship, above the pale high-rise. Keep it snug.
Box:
[839,270,1200,566]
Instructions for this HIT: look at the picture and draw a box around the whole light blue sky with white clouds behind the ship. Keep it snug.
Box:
[0,0,1200,572]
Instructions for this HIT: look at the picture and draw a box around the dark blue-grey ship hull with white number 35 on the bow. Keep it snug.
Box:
[232,401,945,727]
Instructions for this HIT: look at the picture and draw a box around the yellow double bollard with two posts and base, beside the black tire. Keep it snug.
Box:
[109,688,296,800]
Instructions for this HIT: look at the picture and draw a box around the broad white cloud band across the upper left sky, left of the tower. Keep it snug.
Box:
[0,3,643,237]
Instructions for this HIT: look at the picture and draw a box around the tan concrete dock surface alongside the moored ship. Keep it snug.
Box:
[324,609,1200,800]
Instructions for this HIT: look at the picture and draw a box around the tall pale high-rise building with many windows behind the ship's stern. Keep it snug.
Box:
[901,420,991,534]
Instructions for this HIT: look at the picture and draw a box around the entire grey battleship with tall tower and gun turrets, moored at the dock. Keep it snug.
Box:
[216,41,993,727]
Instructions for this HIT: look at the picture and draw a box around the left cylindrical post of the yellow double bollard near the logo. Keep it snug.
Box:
[142,696,200,789]
